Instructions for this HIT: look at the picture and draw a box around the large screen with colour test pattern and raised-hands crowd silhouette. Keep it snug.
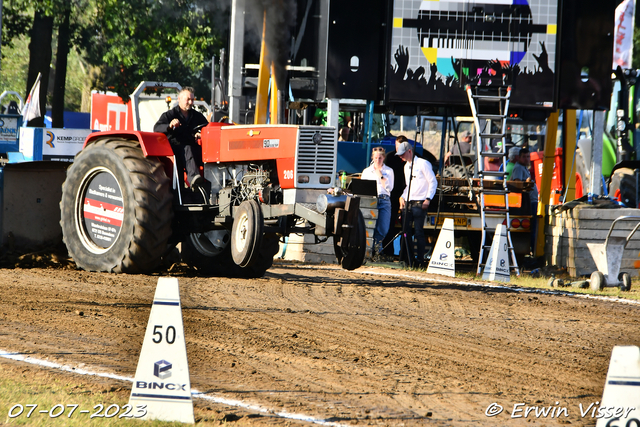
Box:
[388,0,559,109]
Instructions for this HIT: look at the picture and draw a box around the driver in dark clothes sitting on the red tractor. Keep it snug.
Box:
[153,86,209,191]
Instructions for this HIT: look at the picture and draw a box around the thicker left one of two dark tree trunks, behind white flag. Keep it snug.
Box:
[27,11,53,127]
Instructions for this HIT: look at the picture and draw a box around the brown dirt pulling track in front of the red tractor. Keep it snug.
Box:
[0,264,640,426]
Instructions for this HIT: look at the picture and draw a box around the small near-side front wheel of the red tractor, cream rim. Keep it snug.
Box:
[231,200,264,267]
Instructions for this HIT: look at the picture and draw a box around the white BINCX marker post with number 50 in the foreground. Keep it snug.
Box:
[129,277,195,424]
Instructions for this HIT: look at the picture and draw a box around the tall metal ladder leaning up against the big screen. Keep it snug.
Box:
[466,85,520,276]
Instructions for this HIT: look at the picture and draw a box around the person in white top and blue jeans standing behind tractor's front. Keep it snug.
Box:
[361,147,394,257]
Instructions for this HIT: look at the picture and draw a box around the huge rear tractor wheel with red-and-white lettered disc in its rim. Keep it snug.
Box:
[60,138,173,273]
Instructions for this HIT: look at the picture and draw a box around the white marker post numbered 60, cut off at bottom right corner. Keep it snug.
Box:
[588,345,640,427]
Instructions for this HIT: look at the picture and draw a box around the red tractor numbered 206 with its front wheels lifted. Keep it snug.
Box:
[60,123,366,277]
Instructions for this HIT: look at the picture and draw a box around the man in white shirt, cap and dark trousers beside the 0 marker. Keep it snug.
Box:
[396,142,438,267]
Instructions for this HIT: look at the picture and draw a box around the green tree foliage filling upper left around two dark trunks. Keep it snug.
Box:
[0,0,225,111]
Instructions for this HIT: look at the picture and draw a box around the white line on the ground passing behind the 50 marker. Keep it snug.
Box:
[0,350,350,427]
